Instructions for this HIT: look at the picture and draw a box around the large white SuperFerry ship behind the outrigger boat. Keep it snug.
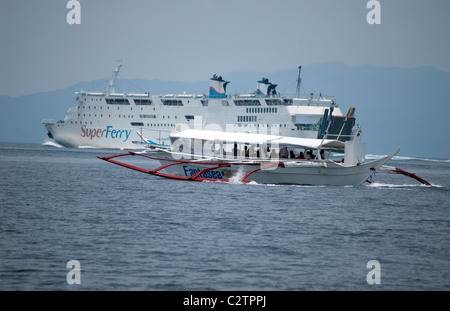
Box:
[42,63,355,149]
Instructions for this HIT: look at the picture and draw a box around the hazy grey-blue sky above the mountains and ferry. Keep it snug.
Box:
[0,0,450,96]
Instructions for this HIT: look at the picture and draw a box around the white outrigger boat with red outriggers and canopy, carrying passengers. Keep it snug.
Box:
[98,129,430,186]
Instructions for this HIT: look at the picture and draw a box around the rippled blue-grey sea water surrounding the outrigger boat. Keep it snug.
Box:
[0,143,450,291]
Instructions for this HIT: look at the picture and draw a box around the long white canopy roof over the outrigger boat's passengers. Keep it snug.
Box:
[170,129,345,149]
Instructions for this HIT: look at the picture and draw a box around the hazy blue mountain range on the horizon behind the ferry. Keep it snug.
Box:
[0,62,450,159]
